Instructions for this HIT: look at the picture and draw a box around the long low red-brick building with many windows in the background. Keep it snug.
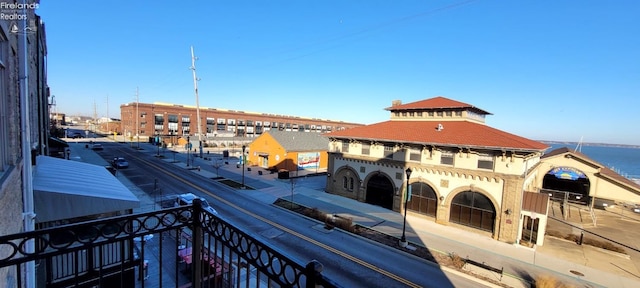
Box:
[120,102,362,143]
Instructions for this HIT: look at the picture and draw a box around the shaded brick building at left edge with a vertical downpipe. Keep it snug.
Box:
[0,1,51,287]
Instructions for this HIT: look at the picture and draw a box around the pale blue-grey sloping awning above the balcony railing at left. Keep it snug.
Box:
[33,156,140,223]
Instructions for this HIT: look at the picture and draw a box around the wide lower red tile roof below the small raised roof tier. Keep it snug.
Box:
[325,121,548,150]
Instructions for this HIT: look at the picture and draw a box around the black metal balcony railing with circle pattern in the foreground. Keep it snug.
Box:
[0,200,339,287]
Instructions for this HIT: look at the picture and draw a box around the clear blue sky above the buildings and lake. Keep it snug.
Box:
[36,0,640,145]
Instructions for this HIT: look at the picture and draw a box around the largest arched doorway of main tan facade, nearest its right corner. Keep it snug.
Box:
[449,191,496,232]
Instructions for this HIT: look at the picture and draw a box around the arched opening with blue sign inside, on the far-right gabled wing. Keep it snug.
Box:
[540,167,590,205]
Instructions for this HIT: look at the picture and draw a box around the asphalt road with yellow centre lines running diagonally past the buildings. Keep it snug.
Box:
[92,142,482,287]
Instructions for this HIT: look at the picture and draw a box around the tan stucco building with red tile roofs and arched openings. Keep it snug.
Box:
[325,97,640,245]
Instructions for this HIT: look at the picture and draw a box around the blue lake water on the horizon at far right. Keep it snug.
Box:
[547,144,640,179]
